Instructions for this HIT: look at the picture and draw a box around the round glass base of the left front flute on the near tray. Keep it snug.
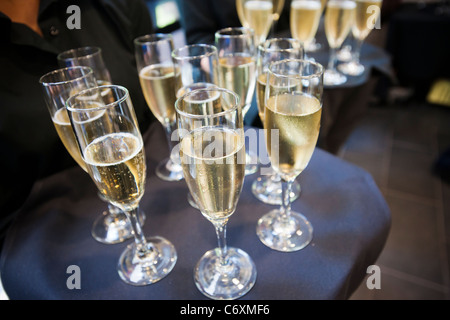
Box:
[118,237,177,286]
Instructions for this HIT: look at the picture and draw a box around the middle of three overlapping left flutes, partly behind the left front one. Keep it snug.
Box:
[39,66,136,244]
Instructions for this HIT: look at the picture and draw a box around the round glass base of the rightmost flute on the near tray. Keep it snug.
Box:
[256,209,313,252]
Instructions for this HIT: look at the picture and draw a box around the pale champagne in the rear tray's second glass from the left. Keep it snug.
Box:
[290,0,322,46]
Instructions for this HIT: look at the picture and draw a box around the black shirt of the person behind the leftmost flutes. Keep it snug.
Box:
[0,0,154,242]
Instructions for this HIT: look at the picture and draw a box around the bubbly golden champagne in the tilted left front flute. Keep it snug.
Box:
[84,133,146,211]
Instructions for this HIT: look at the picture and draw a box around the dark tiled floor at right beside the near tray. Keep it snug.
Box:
[339,94,450,300]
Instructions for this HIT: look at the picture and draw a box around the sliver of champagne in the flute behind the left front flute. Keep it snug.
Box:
[52,108,87,171]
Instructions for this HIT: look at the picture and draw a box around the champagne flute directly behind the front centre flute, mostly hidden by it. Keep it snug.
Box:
[171,44,219,209]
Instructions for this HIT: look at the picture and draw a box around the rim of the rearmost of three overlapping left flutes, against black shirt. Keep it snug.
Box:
[56,47,111,85]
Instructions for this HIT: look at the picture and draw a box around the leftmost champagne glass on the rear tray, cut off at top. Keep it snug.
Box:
[236,0,276,45]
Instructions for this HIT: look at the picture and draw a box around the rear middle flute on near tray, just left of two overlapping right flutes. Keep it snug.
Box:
[215,27,259,175]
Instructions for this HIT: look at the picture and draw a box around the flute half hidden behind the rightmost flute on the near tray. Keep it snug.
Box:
[252,38,304,205]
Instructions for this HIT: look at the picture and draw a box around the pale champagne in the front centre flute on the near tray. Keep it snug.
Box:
[180,127,245,221]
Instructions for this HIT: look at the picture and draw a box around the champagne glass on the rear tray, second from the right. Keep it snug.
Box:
[323,0,356,86]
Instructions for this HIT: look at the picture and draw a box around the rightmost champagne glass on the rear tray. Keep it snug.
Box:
[338,0,382,76]
